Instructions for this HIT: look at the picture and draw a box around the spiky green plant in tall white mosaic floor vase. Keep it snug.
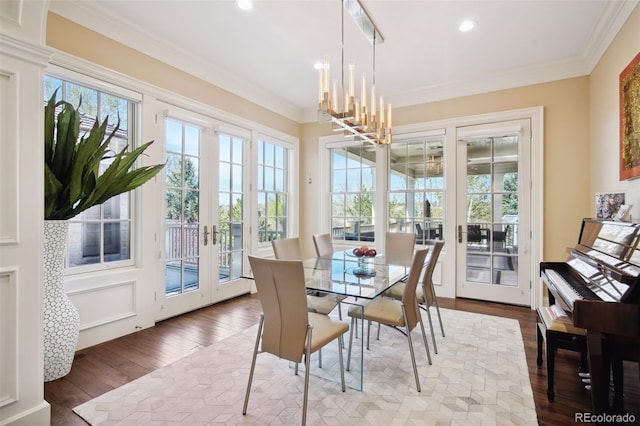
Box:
[43,90,164,381]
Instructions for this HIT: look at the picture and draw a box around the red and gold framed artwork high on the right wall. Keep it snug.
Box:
[620,53,640,180]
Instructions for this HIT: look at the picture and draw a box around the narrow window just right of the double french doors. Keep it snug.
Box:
[258,140,289,244]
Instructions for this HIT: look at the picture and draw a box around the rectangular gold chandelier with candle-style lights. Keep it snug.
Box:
[318,0,391,145]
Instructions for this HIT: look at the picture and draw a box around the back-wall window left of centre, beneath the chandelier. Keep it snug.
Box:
[330,145,376,241]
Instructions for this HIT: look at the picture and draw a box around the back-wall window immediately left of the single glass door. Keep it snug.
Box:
[389,136,445,244]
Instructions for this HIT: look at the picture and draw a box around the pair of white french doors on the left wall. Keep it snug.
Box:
[157,107,249,320]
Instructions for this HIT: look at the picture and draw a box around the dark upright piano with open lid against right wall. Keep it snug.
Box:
[540,219,640,414]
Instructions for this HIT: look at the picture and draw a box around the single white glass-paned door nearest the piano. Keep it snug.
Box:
[456,119,532,306]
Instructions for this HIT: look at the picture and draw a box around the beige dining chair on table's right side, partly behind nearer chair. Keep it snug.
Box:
[378,240,444,353]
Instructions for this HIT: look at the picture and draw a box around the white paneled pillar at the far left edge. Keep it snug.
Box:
[0,0,52,426]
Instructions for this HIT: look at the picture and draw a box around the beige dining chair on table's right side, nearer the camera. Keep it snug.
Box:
[347,248,431,392]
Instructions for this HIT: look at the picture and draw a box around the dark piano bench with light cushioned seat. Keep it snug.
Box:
[536,306,588,401]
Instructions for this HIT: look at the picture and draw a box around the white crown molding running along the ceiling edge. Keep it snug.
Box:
[50,0,640,123]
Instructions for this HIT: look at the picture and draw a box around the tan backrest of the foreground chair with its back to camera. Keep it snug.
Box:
[249,256,309,362]
